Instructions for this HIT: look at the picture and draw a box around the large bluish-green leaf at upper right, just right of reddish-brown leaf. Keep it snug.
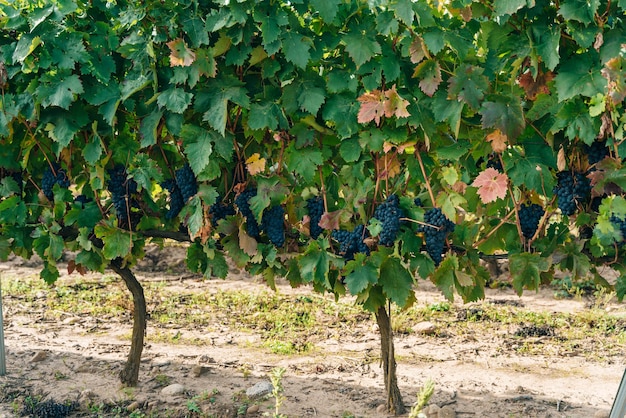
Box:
[554,54,606,102]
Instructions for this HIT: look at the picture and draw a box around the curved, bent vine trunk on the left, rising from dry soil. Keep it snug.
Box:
[111,258,147,386]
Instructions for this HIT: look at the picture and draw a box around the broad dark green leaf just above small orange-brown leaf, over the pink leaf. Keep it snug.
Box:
[480,96,525,140]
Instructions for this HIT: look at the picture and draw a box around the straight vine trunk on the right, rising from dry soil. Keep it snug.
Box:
[376,306,406,415]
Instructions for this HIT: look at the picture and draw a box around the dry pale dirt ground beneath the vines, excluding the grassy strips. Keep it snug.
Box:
[0,247,626,418]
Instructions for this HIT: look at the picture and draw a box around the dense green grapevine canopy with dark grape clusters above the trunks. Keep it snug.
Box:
[0,0,626,311]
